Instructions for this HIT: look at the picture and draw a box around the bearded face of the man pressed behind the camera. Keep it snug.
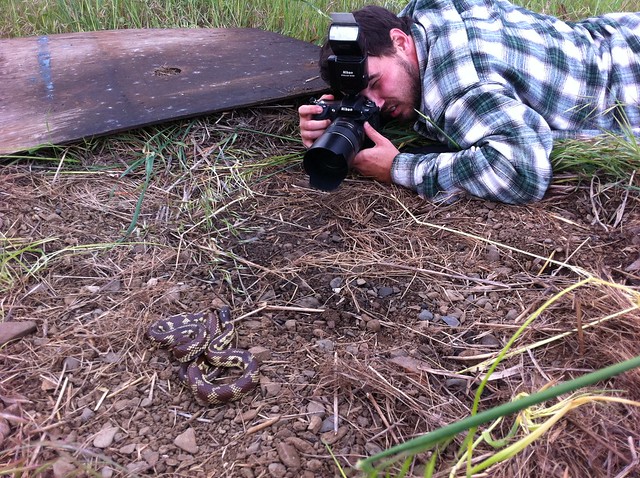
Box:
[360,53,421,121]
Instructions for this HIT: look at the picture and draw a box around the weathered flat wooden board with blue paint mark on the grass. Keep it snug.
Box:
[0,29,327,154]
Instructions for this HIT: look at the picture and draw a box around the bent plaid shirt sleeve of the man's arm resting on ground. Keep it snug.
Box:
[391,84,553,204]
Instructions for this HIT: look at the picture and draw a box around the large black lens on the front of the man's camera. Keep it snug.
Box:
[302,118,364,191]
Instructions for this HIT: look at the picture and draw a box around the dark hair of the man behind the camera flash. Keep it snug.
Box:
[320,5,413,83]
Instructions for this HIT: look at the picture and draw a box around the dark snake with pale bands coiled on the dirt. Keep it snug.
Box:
[147,306,259,405]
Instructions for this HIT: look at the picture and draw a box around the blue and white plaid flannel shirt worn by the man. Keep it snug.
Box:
[391,0,640,204]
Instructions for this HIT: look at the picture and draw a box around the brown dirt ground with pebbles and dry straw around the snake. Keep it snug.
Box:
[0,108,640,478]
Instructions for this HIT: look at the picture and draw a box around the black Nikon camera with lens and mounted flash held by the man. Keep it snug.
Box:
[303,13,380,191]
